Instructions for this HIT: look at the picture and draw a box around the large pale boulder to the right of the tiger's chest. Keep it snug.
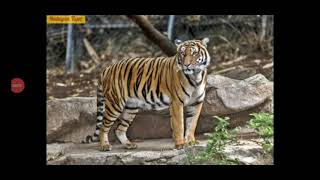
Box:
[202,74,273,115]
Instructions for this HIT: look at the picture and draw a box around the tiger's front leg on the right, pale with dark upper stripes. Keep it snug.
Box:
[185,102,203,145]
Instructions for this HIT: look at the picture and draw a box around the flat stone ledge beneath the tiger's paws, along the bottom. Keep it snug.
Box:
[47,139,273,165]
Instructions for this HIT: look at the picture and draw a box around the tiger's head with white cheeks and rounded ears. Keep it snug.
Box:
[175,38,210,74]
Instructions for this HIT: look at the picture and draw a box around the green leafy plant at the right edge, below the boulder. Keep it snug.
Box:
[248,113,273,153]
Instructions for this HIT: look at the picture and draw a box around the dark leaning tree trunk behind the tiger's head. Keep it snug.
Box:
[127,15,177,56]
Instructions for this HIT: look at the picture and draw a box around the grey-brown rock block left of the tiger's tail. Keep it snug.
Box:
[47,97,97,143]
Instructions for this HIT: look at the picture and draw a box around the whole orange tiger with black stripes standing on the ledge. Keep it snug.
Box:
[86,37,210,151]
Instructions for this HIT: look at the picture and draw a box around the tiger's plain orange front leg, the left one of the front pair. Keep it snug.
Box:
[170,101,185,149]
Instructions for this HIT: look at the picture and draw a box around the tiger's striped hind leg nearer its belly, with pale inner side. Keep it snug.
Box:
[115,108,139,149]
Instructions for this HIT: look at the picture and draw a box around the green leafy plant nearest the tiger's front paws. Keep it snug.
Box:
[188,116,239,165]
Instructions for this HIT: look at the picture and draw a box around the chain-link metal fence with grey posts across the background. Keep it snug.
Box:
[47,15,273,69]
